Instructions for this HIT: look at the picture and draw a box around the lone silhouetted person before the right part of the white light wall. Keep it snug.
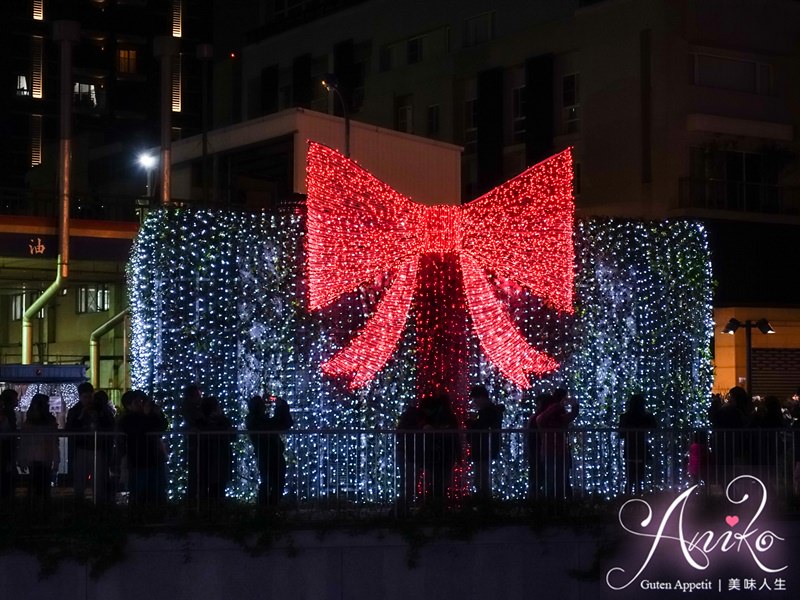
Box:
[618,394,658,495]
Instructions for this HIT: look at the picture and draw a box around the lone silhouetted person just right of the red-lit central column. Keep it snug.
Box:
[466,385,505,498]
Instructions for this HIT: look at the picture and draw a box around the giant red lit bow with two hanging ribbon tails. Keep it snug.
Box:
[306,142,574,388]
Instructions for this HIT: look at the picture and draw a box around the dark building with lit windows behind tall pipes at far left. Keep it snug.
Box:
[0,0,212,387]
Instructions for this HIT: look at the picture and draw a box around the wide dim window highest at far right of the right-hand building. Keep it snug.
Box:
[689,53,772,95]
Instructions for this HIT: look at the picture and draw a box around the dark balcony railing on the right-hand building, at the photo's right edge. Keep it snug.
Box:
[679,178,800,215]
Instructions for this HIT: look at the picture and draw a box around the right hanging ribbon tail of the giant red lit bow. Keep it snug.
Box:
[460,253,559,389]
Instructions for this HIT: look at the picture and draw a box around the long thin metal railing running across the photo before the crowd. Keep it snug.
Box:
[0,429,800,518]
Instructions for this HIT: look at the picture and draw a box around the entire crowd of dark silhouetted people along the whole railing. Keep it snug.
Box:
[0,382,800,505]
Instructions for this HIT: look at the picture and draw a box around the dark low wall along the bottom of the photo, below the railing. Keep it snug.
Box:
[0,521,800,600]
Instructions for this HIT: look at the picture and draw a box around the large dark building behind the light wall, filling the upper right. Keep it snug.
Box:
[237,0,800,395]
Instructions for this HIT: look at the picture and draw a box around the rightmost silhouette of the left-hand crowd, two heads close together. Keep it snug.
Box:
[245,396,293,506]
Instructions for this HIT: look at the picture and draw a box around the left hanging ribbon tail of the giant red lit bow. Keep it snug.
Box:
[322,257,419,389]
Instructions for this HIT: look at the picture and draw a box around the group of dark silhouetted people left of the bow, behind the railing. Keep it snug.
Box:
[0,382,292,506]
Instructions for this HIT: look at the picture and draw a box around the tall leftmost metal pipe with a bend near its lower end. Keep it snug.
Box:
[22,21,80,365]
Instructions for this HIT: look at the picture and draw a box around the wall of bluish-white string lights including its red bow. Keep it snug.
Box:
[129,152,712,501]
